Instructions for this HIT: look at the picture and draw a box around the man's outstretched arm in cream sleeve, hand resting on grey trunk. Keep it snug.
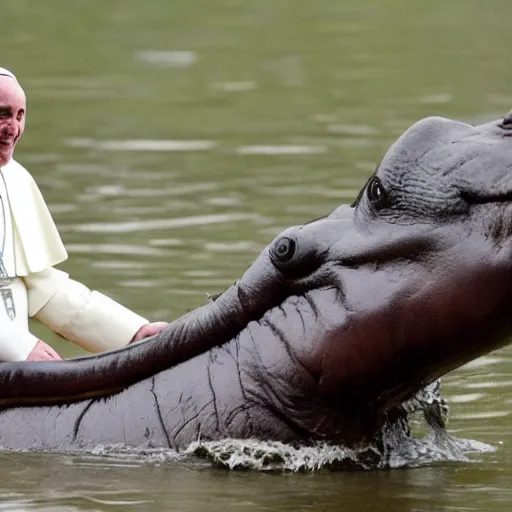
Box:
[23,267,160,352]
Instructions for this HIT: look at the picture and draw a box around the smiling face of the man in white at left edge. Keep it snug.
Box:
[0,76,26,167]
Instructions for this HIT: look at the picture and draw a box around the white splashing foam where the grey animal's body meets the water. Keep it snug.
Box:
[85,381,494,472]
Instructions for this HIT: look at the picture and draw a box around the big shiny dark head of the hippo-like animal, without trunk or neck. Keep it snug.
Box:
[229,111,512,416]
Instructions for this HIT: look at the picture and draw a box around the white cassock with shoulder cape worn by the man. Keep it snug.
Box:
[0,160,148,361]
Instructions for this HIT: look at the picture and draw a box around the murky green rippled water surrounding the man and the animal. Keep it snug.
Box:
[0,0,512,512]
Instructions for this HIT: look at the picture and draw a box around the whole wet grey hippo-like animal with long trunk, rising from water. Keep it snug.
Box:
[0,114,512,451]
